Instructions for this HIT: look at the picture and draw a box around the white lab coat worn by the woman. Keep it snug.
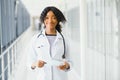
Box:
[27,30,71,80]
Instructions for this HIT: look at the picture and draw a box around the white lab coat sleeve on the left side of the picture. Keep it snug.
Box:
[26,36,37,70]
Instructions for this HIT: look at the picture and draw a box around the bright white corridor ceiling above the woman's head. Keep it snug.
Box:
[21,0,65,16]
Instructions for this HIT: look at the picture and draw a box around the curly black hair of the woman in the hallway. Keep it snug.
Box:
[40,6,66,33]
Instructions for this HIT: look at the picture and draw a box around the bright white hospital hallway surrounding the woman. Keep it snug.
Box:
[0,0,120,80]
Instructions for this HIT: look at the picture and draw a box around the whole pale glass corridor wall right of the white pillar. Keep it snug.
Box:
[84,0,120,80]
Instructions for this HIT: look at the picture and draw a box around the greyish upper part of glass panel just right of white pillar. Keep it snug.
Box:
[87,0,104,53]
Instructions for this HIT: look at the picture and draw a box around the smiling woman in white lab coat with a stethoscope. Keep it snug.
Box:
[28,6,71,80]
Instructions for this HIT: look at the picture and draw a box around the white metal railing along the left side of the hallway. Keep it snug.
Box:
[0,30,27,80]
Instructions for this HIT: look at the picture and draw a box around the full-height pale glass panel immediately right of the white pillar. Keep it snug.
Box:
[85,0,105,80]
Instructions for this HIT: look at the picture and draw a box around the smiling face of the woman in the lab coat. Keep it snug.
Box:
[44,11,58,29]
